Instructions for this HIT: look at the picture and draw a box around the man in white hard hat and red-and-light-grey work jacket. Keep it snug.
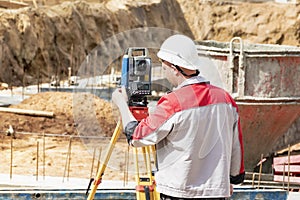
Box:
[112,35,245,199]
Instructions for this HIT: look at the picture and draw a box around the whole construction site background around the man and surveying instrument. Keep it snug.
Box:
[0,0,300,200]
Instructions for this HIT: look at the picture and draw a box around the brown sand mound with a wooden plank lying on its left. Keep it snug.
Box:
[0,92,116,136]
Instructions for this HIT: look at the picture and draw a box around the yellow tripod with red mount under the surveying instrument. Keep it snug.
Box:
[86,106,160,200]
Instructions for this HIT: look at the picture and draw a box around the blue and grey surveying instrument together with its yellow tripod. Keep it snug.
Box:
[86,47,160,200]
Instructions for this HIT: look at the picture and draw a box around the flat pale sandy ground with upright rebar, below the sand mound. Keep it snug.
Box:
[0,134,133,181]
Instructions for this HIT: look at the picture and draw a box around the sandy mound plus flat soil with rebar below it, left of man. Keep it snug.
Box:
[0,92,138,180]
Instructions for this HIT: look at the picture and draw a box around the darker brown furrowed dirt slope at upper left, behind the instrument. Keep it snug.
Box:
[0,0,191,86]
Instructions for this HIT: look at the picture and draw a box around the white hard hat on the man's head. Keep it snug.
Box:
[157,35,201,70]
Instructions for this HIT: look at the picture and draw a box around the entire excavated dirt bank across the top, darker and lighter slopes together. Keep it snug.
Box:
[0,0,300,86]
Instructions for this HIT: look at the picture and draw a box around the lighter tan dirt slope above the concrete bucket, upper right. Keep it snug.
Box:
[178,0,300,46]
